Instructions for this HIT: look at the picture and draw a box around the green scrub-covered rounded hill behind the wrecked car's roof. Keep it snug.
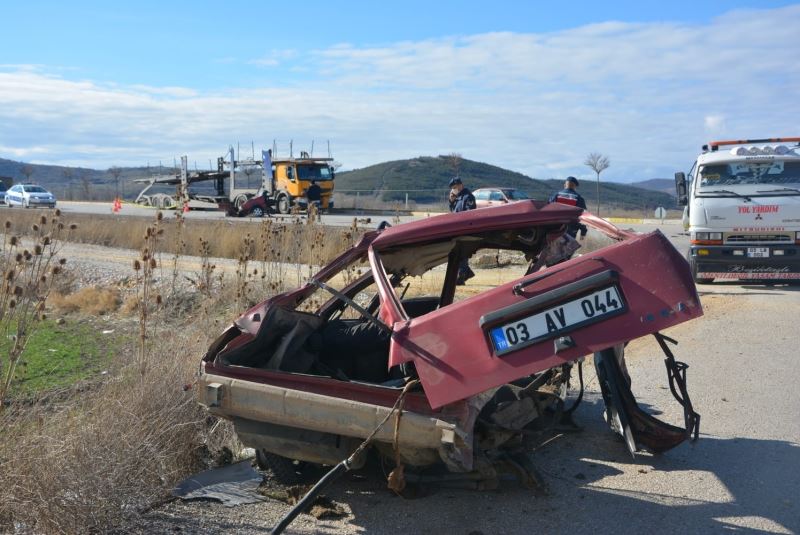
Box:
[336,156,675,210]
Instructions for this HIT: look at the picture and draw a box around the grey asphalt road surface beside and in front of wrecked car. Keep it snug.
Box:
[128,220,800,535]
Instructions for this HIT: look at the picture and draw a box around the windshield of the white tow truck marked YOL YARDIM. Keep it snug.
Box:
[698,160,800,188]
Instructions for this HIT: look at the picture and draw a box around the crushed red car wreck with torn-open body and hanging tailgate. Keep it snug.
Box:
[198,201,702,486]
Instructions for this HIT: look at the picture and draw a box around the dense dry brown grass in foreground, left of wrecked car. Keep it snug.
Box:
[0,340,226,533]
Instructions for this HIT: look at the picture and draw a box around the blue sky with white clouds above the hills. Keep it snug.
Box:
[0,1,800,181]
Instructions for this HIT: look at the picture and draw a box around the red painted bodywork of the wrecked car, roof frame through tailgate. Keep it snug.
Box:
[204,201,702,412]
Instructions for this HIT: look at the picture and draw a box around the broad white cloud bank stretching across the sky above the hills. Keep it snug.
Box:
[0,6,800,180]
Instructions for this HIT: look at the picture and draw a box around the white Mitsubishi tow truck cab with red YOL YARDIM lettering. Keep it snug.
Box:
[675,137,800,283]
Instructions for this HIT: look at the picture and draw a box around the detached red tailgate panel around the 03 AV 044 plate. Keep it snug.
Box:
[389,231,702,408]
